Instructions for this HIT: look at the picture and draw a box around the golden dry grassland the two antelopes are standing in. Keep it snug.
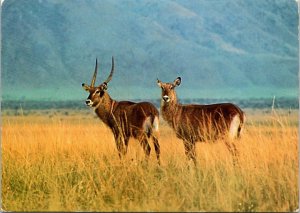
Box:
[2,109,299,212]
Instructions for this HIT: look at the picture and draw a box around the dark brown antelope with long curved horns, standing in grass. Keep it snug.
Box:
[82,57,160,164]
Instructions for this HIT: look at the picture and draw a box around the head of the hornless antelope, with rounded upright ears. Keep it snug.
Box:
[157,77,181,103]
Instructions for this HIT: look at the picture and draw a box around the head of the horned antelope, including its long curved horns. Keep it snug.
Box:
[82,57,114,107]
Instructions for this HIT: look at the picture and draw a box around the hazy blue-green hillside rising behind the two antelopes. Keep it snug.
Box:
[1,0,299,100]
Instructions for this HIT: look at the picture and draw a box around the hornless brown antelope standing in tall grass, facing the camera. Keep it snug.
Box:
[157,77,245,164]
